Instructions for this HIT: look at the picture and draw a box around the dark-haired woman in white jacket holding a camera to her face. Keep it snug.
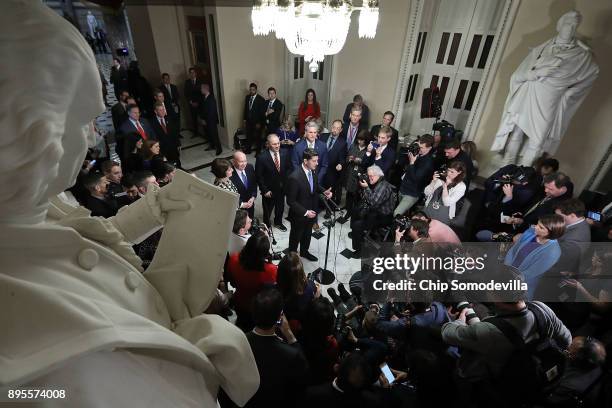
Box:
[424,160,467,224]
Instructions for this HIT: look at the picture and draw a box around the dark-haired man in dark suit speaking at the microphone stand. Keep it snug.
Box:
[287,147,332,262]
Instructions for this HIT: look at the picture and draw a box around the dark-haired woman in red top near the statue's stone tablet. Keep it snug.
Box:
[227,232,276,331]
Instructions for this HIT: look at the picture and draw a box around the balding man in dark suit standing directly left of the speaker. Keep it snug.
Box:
[255,134,291,231]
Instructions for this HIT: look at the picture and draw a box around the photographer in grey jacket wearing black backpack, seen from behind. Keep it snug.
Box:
[442,268,572,407]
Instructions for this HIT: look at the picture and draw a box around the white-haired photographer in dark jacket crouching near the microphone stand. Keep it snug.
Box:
[350,165,396,258]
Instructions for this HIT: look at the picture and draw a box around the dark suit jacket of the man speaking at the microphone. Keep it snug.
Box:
[287,165,323,221]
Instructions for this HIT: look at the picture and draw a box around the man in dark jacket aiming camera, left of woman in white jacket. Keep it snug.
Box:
[393,134,434,216]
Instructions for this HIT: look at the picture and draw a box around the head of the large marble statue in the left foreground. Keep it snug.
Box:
[0,0,104,223]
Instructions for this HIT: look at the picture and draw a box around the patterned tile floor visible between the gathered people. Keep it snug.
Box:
[96,55,360,295]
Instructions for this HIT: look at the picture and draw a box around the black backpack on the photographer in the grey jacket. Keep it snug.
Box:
[486,303,567,402]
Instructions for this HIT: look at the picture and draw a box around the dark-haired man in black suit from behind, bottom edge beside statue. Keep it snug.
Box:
[245,289,308,408]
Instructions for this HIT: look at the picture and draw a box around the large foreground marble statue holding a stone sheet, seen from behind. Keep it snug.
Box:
[0,0,259,408]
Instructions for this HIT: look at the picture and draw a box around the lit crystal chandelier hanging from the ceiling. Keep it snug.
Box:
[251,0,378,72]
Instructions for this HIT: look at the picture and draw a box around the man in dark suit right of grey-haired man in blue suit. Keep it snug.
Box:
[319,119,347,218]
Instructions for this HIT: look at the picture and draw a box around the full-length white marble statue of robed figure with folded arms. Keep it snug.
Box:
[491,11,599,166]
